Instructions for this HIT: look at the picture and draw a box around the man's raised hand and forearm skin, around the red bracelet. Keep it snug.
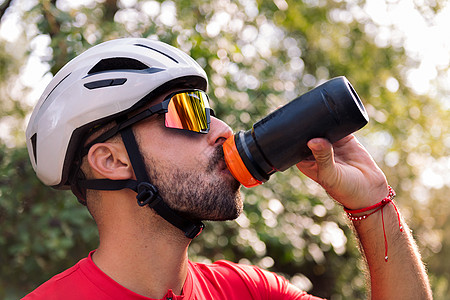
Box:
[297,136,432,299]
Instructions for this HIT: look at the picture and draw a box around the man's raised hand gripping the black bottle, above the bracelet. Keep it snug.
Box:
[297,135,388,209]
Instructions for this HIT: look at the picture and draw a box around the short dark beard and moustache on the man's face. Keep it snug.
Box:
[145,146,243,221]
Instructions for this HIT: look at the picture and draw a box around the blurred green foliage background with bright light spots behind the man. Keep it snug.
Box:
[0,0,450,299]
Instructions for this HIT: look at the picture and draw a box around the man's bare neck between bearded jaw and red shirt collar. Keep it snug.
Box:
[93,192,191,299]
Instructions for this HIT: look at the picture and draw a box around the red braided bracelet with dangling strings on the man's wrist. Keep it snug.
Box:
[344,186,403,262]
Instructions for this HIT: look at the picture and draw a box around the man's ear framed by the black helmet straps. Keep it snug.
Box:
[88,142,134,180]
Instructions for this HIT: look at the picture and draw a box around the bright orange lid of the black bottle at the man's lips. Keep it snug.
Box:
[223,136,262,188]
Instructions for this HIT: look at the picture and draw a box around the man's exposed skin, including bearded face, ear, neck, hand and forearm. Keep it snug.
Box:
[87,90,431,299]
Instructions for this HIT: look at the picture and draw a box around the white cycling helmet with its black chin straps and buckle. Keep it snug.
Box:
[26,38,210,238]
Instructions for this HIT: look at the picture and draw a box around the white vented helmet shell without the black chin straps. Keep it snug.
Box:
[26,38,207,188]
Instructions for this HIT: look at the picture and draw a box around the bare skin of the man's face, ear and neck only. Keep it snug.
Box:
[87,89,242,299]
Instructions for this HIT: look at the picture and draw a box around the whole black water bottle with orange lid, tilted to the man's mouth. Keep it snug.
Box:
[223,76,369,187]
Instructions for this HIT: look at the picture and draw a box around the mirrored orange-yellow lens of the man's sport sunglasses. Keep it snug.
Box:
[165,91,210,133]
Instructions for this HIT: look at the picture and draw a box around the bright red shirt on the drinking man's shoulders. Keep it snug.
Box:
[24,252,319,300]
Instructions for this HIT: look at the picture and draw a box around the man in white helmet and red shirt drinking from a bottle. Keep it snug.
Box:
[25,39,431,299]
